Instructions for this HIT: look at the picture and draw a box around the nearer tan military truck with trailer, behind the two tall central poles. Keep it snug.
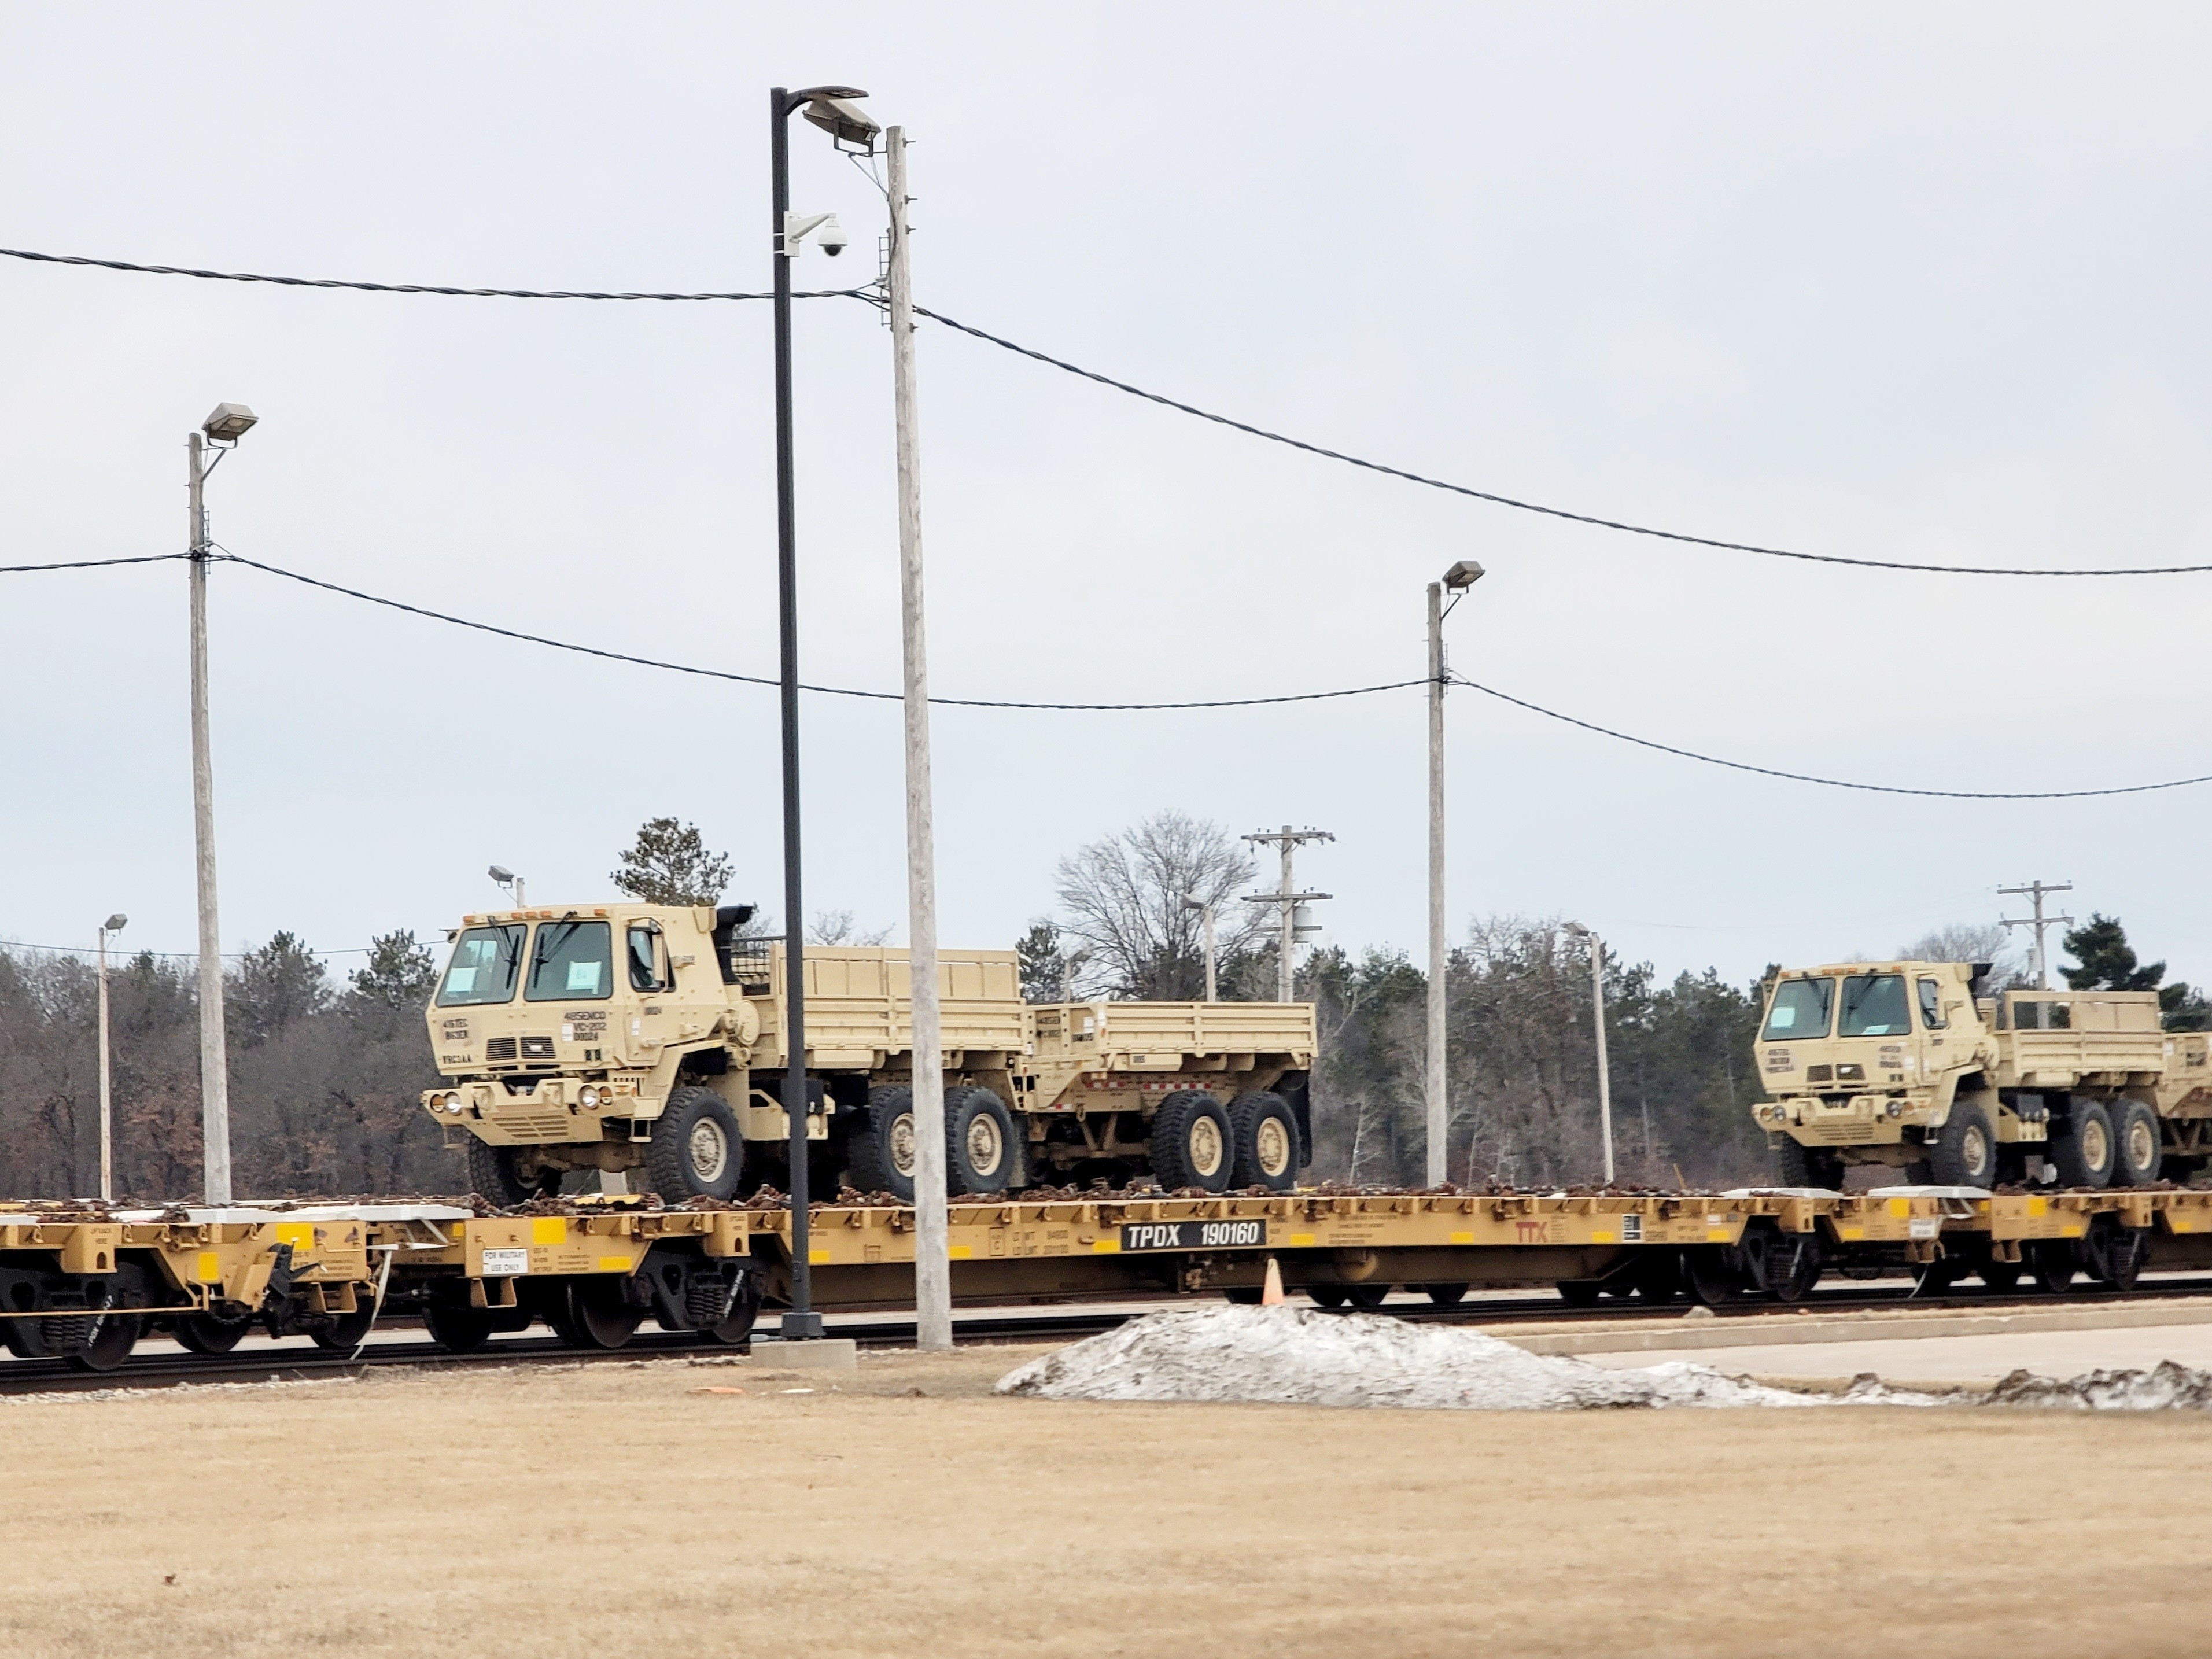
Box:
[422,902,1314,1203]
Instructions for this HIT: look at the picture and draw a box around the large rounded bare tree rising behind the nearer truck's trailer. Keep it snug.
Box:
[1057,808,1272,1002]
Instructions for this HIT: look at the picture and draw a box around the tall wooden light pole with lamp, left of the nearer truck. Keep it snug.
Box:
[186,403,257,1205]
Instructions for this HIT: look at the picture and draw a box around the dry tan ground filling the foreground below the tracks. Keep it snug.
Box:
[0,1350,2212,1659]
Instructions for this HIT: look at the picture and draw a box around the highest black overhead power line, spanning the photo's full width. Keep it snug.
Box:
[0,248,2212,577]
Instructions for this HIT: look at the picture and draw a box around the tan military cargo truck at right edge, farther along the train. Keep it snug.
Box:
[1754,962,2212,1188]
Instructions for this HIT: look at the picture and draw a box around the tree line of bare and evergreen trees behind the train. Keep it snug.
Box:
[0,812,2212,1199]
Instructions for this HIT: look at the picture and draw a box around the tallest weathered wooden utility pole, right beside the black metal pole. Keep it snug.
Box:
[885,126,953,1351]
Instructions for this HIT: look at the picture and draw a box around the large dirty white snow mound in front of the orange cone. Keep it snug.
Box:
[998,1305,1938,1411]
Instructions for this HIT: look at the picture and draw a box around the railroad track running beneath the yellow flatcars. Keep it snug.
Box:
[0,1278,2212,1396]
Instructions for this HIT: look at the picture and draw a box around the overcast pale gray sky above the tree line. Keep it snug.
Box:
[0,0,2212,995]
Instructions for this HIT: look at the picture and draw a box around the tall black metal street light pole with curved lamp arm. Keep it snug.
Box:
[768,86,876,1343]
